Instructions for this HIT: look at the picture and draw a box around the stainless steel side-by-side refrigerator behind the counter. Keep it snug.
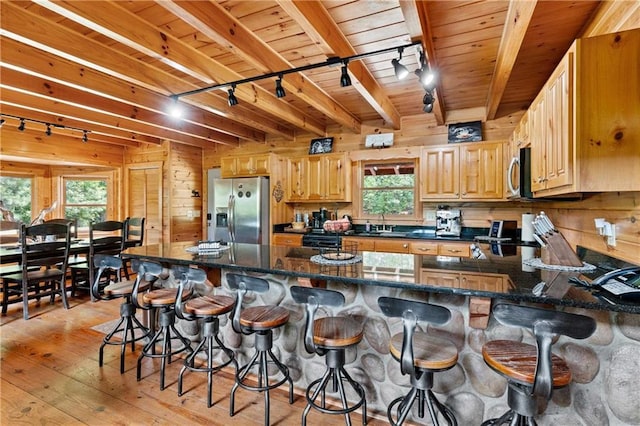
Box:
[213,177,269,245]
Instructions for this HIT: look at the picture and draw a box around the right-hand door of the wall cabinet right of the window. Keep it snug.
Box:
[460,142,504,199]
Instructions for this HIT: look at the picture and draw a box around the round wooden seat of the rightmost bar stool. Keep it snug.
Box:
[482,340,571,388]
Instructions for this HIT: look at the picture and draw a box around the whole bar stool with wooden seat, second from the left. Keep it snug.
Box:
[132,264,193,390]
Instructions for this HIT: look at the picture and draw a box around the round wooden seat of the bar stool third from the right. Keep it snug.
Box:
[313,317,364,348]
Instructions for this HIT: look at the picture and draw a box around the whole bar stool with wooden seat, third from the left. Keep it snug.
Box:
[171,265,238,408]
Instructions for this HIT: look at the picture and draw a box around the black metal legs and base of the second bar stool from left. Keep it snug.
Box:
[136,306,193,390]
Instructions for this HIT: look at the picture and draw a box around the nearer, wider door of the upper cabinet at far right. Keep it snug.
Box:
[544,52,574,189]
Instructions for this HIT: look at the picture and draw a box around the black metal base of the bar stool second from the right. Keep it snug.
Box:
[387,387,458,426]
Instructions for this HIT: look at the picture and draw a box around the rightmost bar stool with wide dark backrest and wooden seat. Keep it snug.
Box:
[482,304,596,426]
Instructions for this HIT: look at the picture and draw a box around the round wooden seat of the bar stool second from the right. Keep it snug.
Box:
[389,331,458,371]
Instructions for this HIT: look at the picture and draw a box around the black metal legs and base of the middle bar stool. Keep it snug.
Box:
[229,330,293,425]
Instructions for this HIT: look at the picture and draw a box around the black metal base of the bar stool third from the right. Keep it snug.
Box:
[302,366,367,426]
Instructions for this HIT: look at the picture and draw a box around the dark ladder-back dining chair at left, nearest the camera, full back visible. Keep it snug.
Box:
[2,223,71,320]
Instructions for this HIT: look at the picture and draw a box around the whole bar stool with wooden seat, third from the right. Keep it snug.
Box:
[291,286,367,425]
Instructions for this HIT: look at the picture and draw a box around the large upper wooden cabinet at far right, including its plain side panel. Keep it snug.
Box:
[529,30,640,197]
